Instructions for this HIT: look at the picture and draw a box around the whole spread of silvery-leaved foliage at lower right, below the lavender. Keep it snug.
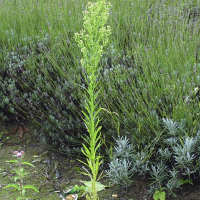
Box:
[107,118,200,196]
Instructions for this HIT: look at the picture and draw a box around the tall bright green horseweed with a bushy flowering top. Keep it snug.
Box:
[75,1,111,199]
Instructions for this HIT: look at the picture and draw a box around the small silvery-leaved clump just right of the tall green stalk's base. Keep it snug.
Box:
[107,134,150,187]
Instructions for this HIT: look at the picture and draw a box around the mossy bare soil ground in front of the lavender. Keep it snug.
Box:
[0,122,200,200]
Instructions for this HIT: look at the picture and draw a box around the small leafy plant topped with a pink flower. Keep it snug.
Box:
[4,151,39,200]
